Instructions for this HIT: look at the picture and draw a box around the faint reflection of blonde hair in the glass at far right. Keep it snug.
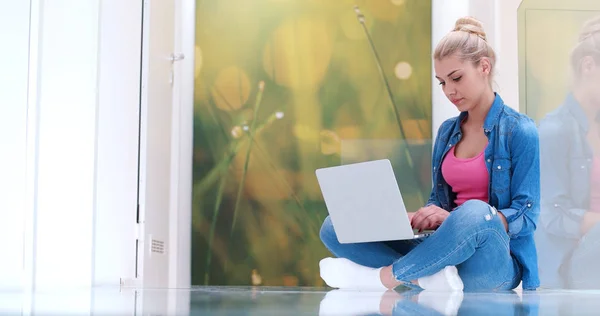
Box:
[571,16,600,77]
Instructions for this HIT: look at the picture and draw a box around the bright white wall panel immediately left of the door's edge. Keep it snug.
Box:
[93,0,142,285]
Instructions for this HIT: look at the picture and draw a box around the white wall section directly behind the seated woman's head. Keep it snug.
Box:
[432,0,522,137]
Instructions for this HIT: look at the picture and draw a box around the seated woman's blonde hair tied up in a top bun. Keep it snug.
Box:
[433,17,496,75]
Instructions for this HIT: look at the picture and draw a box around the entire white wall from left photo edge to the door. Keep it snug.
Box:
[0,0,141,296]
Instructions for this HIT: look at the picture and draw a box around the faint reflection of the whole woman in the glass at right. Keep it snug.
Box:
[536,17,600,288]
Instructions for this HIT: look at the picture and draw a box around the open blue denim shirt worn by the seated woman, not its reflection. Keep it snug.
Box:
[427,94,540,290]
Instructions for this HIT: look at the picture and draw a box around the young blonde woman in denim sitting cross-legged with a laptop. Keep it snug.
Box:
[320,17,540,291]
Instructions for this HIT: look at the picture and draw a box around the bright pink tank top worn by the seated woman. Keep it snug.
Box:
[442,147,489,206]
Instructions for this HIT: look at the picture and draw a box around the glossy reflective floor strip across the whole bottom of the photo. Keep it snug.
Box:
[0,287,600,316]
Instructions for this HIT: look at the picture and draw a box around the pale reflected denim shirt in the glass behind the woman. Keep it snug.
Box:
[536,94,593,288]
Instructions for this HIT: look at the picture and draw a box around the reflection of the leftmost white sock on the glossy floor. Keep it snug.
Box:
[319,290,386,316]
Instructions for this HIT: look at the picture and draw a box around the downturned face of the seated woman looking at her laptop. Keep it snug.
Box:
[434,55,491,112]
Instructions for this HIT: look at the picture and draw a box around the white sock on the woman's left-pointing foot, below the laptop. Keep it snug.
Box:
[319,258,387,291]
